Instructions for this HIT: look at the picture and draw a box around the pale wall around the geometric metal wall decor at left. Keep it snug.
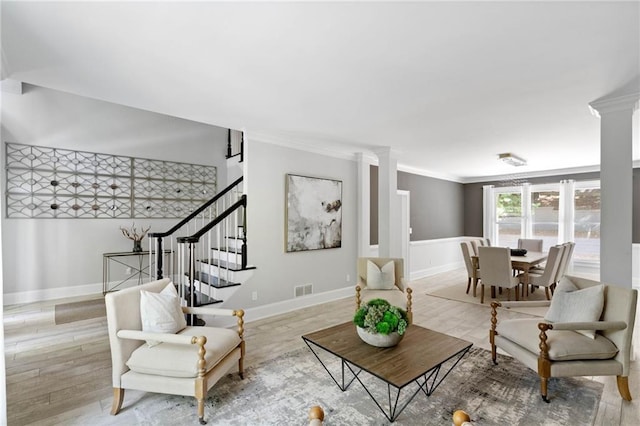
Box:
[0,85,227,304]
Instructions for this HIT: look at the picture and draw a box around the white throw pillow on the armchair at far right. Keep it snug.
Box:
[544,280,604,339]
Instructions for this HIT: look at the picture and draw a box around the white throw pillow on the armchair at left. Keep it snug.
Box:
[140,283,187,346]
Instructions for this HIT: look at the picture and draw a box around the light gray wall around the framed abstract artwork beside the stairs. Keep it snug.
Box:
[228,135,357,312]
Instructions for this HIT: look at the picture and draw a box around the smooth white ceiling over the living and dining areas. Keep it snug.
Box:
[2,0,640,181]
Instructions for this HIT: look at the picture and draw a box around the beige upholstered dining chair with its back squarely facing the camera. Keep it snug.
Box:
[478,246,520,303]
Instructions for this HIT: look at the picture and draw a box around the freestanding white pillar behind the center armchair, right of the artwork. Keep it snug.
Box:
[376,147,402,257]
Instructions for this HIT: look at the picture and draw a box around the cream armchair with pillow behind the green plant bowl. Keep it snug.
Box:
[356,257,413,322]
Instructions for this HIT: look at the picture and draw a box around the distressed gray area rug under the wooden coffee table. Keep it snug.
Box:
[65,347,603,426]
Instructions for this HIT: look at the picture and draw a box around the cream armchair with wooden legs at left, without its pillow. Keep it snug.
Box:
[105,279,245,424]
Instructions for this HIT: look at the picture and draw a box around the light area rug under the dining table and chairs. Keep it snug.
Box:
[427,281,549,316]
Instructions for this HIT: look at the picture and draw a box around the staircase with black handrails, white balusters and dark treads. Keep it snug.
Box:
[149,131,255,306]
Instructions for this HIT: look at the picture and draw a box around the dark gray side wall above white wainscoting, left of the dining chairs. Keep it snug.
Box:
[370,166,464,244]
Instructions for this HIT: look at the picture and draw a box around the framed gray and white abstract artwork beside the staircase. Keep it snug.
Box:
[285,174,342,252]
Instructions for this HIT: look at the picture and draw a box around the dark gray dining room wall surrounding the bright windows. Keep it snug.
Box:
[464,169,640,243]
